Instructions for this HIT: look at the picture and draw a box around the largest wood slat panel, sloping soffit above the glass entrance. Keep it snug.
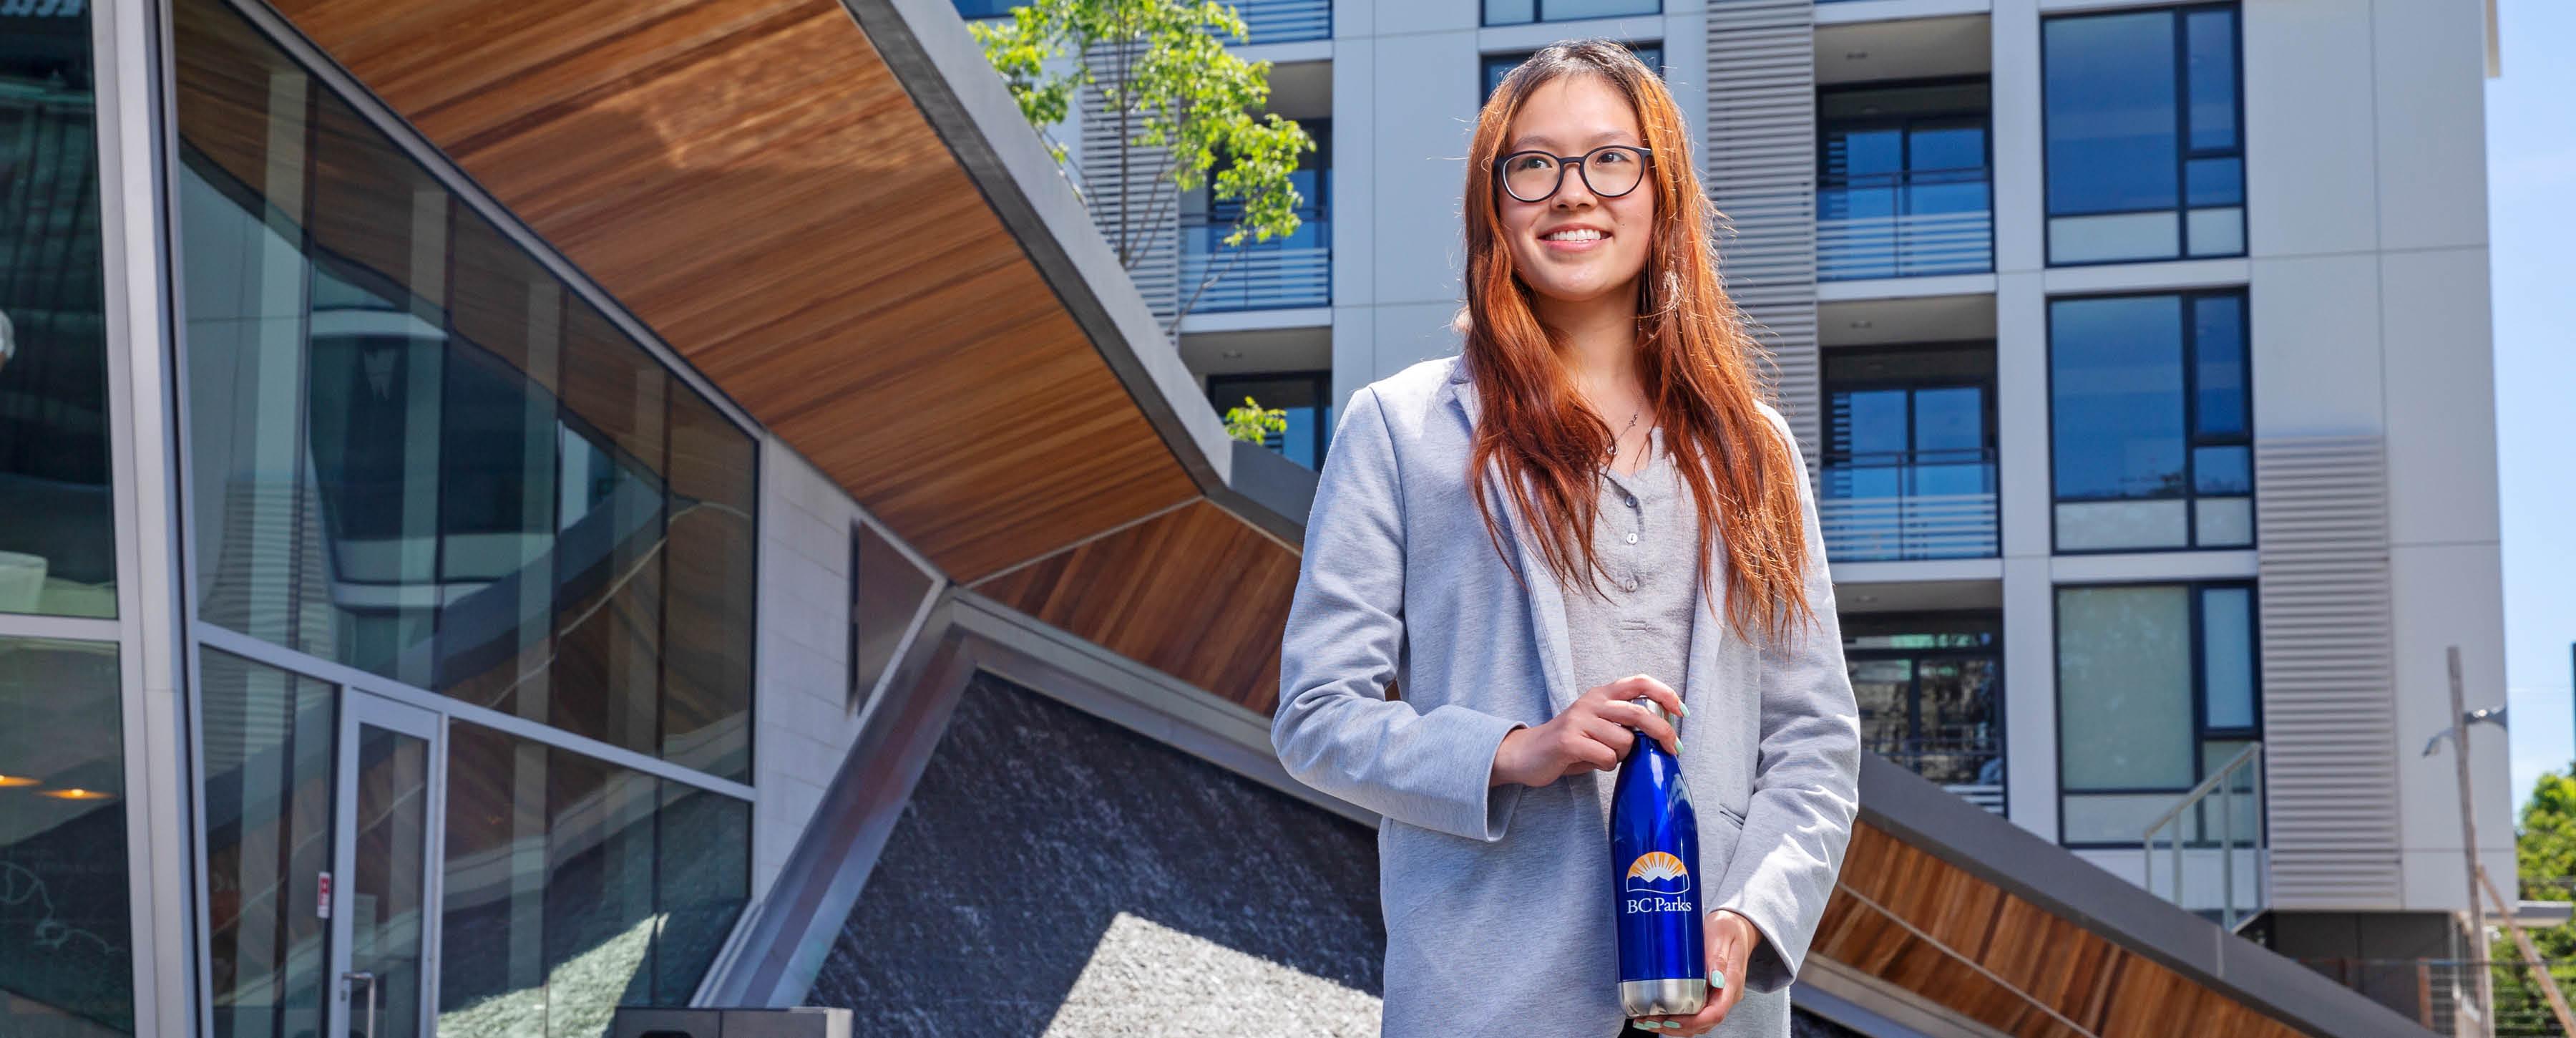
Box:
[275,0,1198,582]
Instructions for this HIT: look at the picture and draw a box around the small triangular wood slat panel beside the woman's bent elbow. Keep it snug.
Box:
[974,500,1298,716]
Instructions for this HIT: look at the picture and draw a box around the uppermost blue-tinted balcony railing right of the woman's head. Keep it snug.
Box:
[1816,170,1994,281]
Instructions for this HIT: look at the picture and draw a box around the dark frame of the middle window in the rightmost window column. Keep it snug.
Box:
[2040,286,2262,556]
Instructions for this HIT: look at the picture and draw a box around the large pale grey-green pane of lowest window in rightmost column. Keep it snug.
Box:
[2058,585,2192,791]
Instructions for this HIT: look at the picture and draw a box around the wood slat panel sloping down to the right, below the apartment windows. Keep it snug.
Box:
[1808,822,2298,1038]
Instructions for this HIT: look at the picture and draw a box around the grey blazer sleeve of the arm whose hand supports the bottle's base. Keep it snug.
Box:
[1710,404,1860,991]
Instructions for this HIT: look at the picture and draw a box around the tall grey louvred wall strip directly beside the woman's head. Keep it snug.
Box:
[1700,0,1824,469]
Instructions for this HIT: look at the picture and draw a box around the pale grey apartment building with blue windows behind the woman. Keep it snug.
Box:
[989,0,2512,1019]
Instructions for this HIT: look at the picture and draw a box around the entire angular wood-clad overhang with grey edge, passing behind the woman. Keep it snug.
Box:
[273,0,2421,1035]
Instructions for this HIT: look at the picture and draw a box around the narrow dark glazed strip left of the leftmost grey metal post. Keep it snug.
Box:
[0,5,137,1038]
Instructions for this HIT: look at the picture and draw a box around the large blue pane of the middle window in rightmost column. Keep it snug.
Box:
[2048,296,2187,500]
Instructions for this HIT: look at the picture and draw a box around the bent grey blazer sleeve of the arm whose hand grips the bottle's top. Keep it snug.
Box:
[1270,387,1523,843]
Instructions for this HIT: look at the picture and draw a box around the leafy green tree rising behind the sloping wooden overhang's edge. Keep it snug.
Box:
[969,0,1314,322]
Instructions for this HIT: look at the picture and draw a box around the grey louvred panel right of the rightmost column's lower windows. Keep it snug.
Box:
[2254,435,2399,909]
